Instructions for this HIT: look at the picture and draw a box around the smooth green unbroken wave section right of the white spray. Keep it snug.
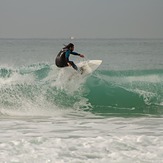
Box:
[87,70,163,114]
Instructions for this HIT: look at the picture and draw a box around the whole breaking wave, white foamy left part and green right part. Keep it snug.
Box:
[0,63,163,115]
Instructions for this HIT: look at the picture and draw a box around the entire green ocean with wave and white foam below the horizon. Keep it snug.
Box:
[0,39,163,163]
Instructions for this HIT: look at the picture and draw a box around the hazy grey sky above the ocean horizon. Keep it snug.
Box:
[0,0,163,38]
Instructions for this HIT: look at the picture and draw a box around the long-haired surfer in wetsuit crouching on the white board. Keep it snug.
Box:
[55,43,84,71]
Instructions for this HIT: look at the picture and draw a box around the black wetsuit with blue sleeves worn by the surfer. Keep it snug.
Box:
[55,49,80,70]
